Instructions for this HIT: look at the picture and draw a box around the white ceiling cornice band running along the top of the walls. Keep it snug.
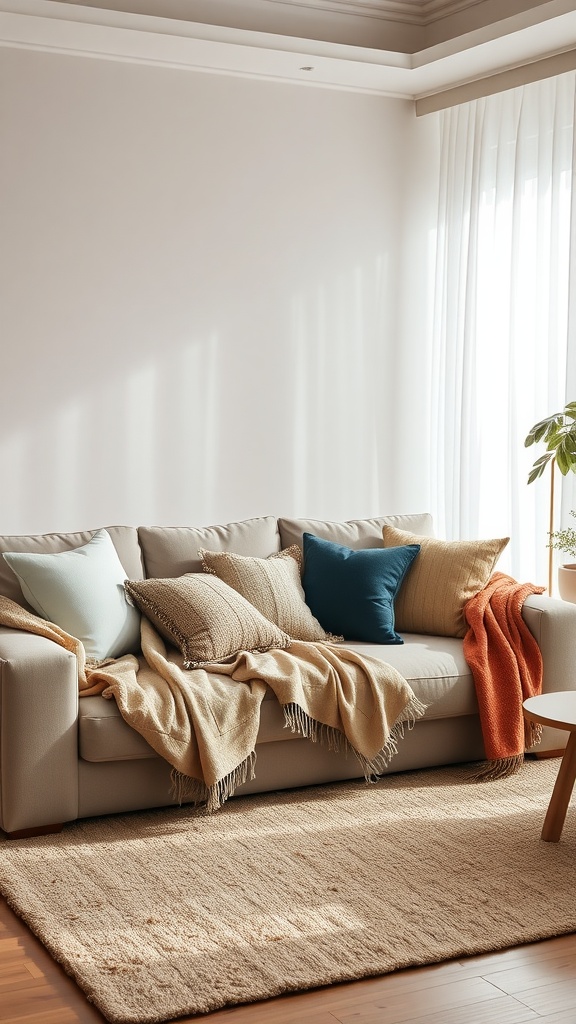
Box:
[0,0,576,111]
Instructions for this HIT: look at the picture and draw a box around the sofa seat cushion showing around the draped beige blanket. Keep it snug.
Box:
[79,634,478,761]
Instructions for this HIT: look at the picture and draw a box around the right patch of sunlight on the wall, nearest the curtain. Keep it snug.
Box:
[290,257,389,518]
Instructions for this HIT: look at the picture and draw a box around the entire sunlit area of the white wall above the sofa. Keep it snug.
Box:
[0,257,398,534]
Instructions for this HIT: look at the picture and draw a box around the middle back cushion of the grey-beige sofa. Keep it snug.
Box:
[138,515,282,580]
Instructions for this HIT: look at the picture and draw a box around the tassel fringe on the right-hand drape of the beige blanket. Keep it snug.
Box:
[284,694,426,782]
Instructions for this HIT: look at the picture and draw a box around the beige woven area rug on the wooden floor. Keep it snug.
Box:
[0,760,576,1024]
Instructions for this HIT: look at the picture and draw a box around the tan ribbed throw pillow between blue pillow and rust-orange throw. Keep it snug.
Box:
[382,526,509,637]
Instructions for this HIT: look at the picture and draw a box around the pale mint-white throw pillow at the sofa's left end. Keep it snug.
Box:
[4,529,140,662]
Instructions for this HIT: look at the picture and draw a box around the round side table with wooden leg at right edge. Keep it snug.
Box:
[523,690,576,843]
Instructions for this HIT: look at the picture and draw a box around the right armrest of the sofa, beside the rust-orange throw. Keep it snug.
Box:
[522,594,576,754]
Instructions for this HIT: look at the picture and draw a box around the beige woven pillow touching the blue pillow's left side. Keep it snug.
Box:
[199,545,330,641]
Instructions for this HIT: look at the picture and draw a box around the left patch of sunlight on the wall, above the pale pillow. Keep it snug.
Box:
[0,336,218,534]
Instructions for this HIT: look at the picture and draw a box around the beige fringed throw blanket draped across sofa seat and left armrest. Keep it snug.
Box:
[0,596,425,811]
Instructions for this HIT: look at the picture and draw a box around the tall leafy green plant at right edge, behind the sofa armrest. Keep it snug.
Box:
[524,401,576,600]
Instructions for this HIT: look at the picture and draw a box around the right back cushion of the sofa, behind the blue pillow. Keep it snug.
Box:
[278,512,434,550]
